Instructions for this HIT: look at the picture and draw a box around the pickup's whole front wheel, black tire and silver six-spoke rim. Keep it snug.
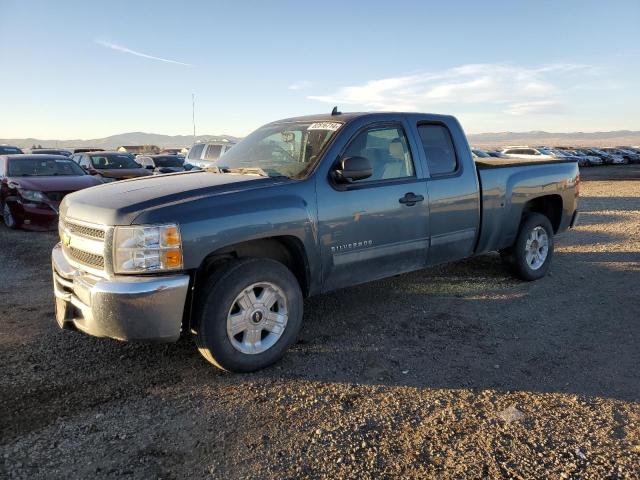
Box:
[196,258,302,372]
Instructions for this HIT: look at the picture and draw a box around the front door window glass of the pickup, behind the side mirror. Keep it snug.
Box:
[343,126,415,182]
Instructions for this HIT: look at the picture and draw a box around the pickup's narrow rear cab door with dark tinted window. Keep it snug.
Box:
[412,116,480,265]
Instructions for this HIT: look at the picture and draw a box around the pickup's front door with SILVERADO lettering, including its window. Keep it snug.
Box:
[316,116,429,291]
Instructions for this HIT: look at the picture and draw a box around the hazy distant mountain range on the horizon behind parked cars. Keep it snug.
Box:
[0,130,640,149]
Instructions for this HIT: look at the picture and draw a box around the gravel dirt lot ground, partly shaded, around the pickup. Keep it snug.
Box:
[0,165,640,479]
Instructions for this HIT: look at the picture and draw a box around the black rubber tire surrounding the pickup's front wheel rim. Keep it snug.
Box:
[196,258,303,372]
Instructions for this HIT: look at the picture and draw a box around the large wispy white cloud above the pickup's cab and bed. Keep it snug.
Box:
[308,63,592,115]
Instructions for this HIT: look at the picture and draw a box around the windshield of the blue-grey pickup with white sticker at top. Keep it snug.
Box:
[216,122,342,178]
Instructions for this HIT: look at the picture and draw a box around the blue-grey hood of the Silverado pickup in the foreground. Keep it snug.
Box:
[60,171,290,225]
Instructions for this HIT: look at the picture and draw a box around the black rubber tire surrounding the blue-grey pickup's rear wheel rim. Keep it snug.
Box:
[508,213,553,282]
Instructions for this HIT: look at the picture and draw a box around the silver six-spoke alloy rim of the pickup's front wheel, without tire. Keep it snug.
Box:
[227,282,289,354]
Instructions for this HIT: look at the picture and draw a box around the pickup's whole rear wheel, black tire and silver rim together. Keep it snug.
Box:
[507,213,553,281]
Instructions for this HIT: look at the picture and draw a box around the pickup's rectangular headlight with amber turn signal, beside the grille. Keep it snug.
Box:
[113,224,183,273]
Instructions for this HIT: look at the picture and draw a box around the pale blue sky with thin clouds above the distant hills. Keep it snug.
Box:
[0,0,640,139]
